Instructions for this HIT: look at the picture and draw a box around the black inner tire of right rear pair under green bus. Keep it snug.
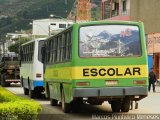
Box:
[111,100,121,112]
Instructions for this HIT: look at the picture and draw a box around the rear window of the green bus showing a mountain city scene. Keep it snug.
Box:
[79,25,141,57]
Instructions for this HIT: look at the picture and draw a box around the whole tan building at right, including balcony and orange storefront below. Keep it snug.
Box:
[102,0,160,79]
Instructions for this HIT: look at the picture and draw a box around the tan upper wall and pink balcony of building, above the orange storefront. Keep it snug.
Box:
[105,0,160,34]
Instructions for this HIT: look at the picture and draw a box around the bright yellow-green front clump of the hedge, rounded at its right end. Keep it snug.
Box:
[0,100,41,120]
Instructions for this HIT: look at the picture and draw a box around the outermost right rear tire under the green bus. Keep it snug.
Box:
[121,97,131,112]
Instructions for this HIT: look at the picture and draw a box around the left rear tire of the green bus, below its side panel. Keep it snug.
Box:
[61,89,71,113]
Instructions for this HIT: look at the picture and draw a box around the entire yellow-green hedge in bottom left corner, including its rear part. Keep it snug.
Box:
[0,87,41,120]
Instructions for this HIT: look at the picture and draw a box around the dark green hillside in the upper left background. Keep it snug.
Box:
[0,0,74,39]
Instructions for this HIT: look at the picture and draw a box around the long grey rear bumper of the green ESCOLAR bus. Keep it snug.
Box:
[73,86,148,97]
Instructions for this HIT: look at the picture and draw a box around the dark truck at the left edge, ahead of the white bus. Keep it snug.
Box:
[0,52,20,87]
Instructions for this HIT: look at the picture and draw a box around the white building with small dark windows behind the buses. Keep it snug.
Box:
[32,18,73,36]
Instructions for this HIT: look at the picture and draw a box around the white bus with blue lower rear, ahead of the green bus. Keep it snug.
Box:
[20,38,45,98]
